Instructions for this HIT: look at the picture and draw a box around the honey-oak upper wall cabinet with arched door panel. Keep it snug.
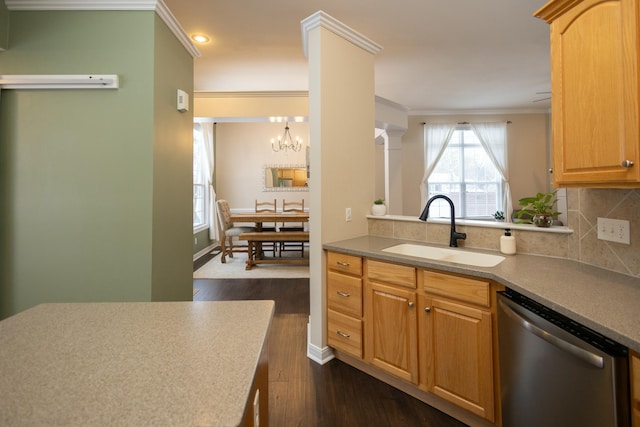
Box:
[535,0,640,187]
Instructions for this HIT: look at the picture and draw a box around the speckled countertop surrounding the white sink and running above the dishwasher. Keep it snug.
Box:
[323,236,640,351]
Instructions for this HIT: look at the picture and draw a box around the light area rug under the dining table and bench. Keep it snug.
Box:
[193,253,309,279]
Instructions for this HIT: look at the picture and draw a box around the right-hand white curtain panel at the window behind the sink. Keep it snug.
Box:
[471,122,513,222]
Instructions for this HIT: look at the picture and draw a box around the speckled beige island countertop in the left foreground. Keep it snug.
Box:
[0,301,274,427]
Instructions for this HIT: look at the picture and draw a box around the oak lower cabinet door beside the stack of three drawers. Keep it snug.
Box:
[365,282,418,384]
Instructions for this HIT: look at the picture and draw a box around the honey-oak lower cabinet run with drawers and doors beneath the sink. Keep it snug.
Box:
[327,251,500,427]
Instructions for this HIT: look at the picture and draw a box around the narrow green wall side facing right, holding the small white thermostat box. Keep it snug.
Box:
[151,16,193,300]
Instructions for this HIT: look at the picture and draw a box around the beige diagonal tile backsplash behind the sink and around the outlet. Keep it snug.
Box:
[369,189,640,277]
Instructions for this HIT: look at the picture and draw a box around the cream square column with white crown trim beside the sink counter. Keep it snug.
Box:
[302,11,381,363]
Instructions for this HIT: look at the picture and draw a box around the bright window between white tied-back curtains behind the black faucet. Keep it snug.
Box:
[427,127,504,219]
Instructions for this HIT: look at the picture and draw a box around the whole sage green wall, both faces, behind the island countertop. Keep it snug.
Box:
[0,11,193,318]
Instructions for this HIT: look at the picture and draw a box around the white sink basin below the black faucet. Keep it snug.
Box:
[382,243,504,267]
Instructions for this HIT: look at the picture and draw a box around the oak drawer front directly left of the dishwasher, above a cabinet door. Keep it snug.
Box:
[422,270,491,307]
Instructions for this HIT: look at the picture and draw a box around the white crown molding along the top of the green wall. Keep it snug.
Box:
[5,0,201,58]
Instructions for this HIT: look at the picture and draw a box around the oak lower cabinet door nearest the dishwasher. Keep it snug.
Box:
[418,295,494,421]
